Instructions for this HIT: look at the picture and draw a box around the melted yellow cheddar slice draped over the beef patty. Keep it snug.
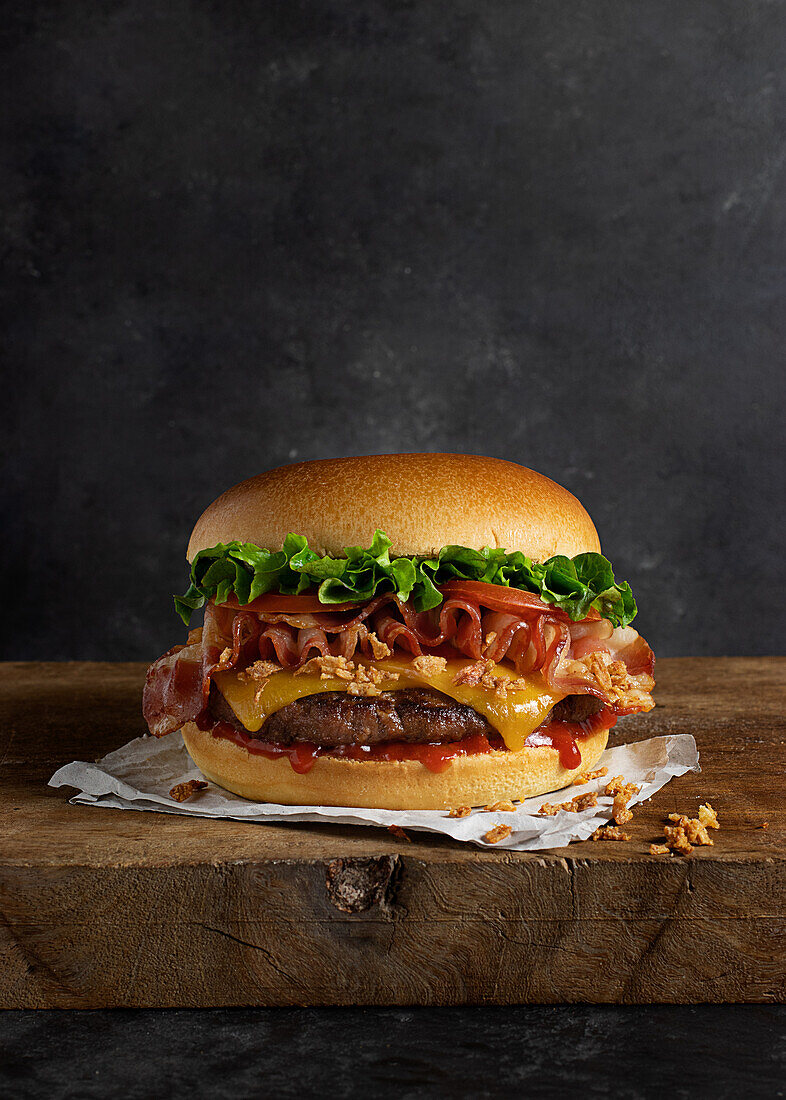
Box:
[213,658,564,751]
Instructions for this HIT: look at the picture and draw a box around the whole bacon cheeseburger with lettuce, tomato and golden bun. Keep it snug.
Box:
[143,454,654,810]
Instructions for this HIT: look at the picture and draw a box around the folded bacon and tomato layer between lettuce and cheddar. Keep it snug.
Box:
[143,580,654,737]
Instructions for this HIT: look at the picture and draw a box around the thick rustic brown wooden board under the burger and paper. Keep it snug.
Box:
[0,658,786,1008]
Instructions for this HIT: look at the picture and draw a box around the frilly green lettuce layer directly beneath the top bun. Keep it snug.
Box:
[175,531,636,626]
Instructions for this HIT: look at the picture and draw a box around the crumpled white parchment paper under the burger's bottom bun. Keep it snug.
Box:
[49,734,700,851]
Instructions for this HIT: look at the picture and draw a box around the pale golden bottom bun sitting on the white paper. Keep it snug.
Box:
[182,723,609,810]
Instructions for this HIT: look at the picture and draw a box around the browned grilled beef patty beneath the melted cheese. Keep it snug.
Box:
[210,684,602,748]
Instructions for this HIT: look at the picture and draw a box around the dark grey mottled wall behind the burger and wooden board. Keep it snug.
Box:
[0,0,786,659]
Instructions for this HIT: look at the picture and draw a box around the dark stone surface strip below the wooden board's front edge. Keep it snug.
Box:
[0,1005,786,1100]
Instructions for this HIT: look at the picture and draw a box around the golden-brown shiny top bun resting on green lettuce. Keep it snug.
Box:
[187,454,600,561]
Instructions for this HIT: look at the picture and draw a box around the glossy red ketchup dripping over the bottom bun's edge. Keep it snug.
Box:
[200,707,617,776]
